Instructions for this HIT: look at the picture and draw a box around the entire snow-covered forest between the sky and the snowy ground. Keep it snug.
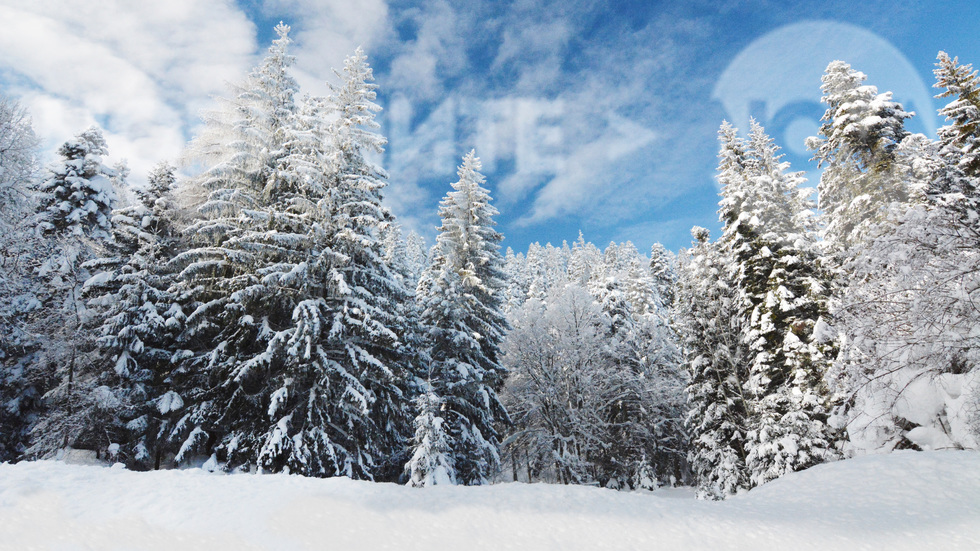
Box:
[0,24,980,499]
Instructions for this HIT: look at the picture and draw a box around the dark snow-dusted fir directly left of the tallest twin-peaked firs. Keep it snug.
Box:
[84,163,186,469]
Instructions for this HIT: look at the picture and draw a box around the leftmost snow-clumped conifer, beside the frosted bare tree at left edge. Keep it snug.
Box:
[27,127,119,457]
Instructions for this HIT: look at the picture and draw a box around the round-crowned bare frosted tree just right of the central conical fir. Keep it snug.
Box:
[504,286,623,484]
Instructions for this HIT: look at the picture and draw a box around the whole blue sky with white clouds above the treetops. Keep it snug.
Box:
[0,0,980,250]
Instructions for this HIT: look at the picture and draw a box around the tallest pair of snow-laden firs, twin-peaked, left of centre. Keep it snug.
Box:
[172,32,413,479]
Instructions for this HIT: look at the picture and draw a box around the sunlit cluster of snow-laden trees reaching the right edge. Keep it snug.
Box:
[674,52,980,499]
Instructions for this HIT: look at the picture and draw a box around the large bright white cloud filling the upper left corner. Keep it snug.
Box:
[0,0,255,185]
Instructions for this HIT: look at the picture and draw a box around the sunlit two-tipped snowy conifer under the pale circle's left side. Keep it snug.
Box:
[719,121,836,485]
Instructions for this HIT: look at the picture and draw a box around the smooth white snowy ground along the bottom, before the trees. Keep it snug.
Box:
[0,452,980,551]
